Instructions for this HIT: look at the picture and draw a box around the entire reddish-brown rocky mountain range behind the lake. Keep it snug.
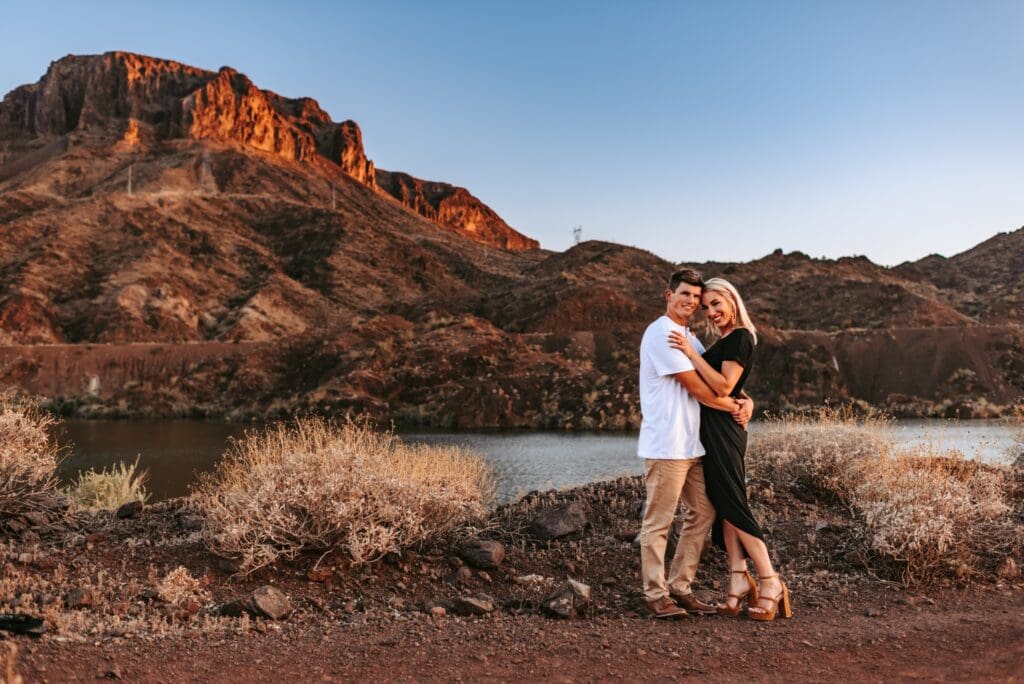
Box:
[0,52,1024,429]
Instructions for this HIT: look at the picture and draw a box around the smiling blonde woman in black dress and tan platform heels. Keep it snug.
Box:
[669,277,793,621]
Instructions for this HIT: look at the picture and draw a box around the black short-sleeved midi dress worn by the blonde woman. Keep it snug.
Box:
[700,328,764,549]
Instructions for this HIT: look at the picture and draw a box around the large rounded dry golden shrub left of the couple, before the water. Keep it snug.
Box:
[193,418,494,572]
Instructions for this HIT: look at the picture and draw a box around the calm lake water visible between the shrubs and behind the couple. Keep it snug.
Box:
[60,420,1015,501]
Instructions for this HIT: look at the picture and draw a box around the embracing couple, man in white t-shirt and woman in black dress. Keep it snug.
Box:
[637,269,792,621]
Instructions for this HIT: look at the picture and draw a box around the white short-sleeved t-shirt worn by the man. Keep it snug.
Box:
[637,315,705,459]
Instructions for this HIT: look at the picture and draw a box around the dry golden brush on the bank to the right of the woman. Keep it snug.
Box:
[750,412,1024,584]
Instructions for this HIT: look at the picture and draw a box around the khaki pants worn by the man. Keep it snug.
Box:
[640,459,715,601]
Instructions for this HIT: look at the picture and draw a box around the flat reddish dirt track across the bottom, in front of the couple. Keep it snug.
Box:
[18,590,1024,682]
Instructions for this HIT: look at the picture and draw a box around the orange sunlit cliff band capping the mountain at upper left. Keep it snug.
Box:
[0,52,540,250]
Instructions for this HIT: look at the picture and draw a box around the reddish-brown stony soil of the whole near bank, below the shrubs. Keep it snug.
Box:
[6,478,1024,682]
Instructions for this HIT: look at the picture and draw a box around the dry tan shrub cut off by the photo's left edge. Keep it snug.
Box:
[0,393,58,520]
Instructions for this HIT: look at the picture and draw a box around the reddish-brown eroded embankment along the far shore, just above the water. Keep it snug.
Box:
[0,316,1024,421]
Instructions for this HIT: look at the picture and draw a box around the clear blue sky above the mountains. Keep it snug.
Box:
[0,0,1024,264]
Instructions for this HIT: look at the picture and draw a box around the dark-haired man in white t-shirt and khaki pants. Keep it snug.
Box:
[637,269,753,617]
